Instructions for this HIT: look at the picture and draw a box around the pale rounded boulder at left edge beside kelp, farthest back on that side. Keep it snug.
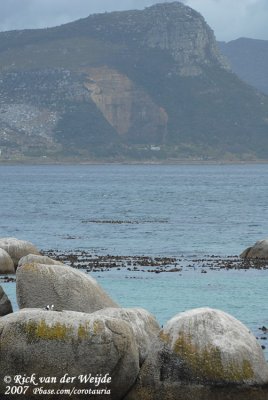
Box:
[0,238,40,267]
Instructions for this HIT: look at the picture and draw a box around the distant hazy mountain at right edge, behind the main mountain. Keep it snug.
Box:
[218,38,268,95]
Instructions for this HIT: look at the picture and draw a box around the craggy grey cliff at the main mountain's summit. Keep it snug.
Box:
[143,2,227,76]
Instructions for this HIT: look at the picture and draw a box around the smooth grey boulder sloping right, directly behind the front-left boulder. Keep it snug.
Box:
[16,263,118,313]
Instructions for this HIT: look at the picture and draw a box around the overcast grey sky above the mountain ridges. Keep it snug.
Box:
[0,0,268,41]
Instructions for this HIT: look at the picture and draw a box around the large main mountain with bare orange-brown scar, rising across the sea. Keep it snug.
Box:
[0,2,268,161]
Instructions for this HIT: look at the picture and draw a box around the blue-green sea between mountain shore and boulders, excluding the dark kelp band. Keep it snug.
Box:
[0,164,268,359]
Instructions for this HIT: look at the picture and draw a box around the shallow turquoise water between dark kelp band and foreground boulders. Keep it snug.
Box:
[2,268,268,360]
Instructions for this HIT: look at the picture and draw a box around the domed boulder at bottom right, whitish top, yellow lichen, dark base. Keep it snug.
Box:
[124,308,268,400]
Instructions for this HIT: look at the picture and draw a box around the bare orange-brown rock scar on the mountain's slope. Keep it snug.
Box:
[85,67,168,143]
